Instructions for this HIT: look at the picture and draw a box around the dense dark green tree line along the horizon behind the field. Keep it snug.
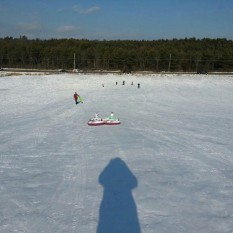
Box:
[0,36,233,72]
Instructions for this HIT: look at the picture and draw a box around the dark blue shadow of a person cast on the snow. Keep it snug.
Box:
[97,158,141,233]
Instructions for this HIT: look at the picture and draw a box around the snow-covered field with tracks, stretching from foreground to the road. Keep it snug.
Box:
[0,74,233,233]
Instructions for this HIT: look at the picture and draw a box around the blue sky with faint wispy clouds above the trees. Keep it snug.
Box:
[0,0,233,40]
